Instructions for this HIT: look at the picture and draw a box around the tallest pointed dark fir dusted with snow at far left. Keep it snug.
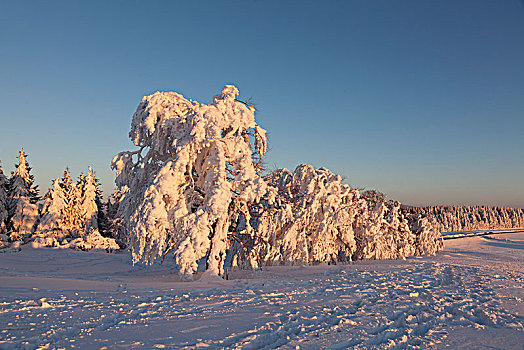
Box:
[9,148,39,239]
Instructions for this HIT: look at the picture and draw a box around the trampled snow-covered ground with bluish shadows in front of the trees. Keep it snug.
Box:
[0,233,524,350]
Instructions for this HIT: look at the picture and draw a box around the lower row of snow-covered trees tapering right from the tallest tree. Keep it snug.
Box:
[241,165,441,267]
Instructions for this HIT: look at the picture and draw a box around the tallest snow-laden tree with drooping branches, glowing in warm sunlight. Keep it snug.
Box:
[112,85,267,274]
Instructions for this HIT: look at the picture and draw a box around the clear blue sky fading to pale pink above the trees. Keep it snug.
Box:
[0,0,524,207]
